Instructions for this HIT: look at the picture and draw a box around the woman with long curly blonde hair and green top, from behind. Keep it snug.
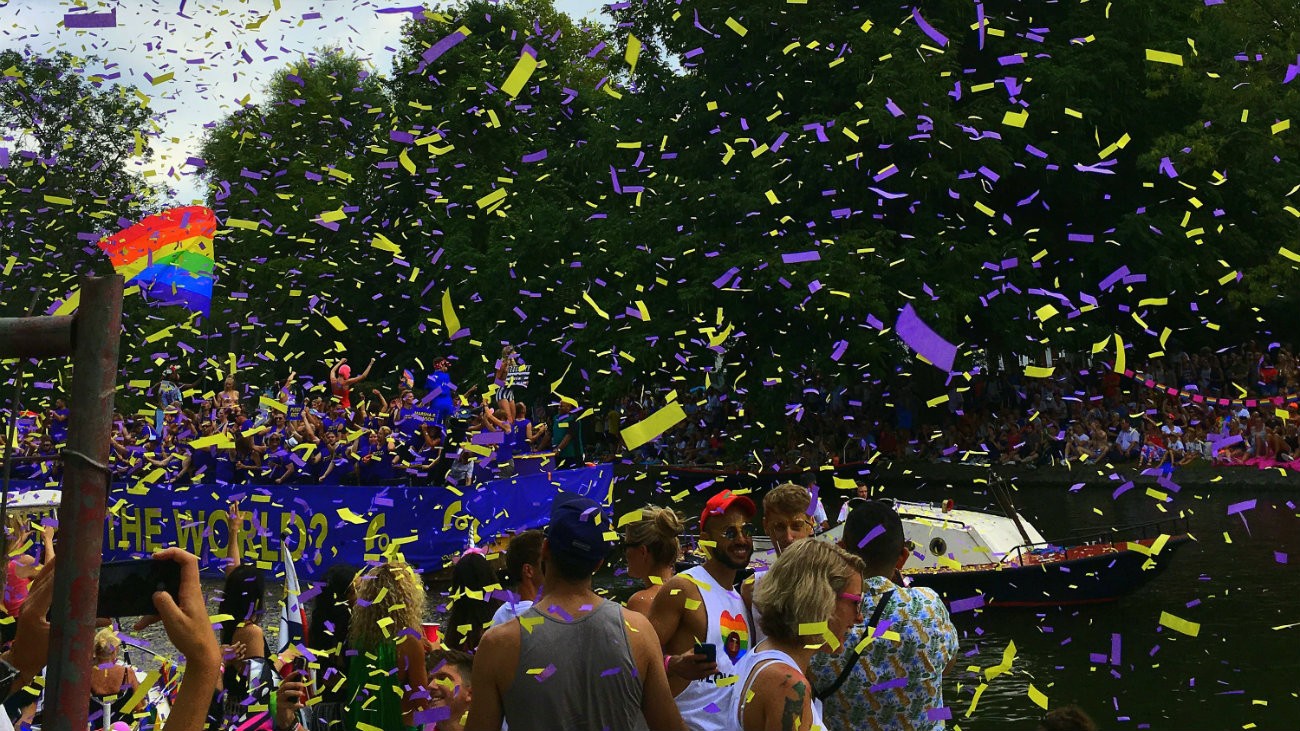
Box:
[347,561,429,731]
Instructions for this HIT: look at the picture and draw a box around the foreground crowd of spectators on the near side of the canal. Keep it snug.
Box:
[0,483,1095,731]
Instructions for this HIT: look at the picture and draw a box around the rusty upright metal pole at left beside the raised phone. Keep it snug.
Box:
[46,274,122,731]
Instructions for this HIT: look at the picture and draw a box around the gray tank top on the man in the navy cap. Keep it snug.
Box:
[502,601,647,731]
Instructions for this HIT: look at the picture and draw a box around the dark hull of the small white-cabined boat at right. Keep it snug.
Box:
[904,536,1190,609]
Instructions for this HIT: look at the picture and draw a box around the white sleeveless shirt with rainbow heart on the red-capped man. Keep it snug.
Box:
[675,566,753,731]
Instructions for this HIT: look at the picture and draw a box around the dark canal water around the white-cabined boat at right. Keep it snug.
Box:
[147,473,1300,731]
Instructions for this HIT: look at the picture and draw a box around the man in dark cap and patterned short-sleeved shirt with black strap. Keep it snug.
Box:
[809,501,957,731]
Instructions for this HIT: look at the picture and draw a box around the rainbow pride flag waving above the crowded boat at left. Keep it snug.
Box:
[51,206,217,315]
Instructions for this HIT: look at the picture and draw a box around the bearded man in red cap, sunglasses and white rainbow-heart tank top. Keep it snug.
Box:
[650,490,757,731]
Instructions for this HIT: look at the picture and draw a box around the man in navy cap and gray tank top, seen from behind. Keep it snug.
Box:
[465,493,683,731]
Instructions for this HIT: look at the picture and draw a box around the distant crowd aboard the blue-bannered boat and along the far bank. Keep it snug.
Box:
[5,343,1300,485]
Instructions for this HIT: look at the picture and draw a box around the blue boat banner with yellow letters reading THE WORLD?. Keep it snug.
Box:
[12,464,614,574]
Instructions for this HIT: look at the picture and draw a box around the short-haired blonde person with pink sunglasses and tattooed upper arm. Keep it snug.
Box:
[724,540,866,731]
